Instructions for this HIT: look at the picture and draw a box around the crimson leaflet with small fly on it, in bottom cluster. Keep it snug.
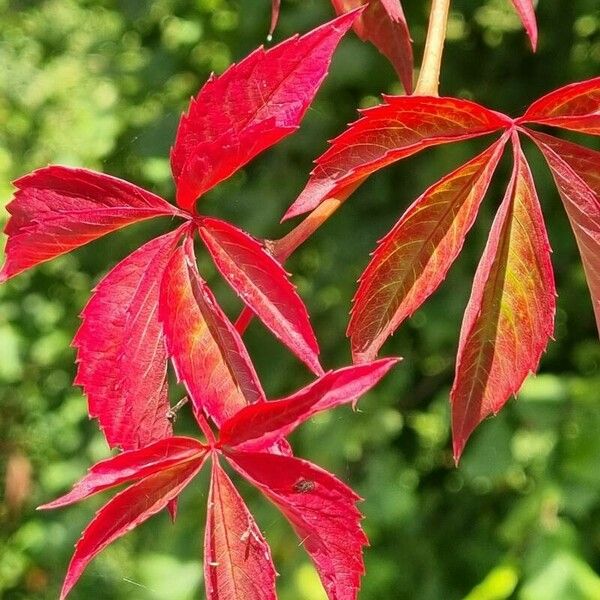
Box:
[228,452,368,600]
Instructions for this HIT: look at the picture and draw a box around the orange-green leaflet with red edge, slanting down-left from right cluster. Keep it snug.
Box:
[348,137,506,362]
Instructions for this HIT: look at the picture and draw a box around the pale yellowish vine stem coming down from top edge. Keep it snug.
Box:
[415,0,450,96]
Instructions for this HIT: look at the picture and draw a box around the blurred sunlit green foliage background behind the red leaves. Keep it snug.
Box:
[0,0,600,600]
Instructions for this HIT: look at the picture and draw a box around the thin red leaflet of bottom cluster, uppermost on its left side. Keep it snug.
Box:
[38,437,208,510]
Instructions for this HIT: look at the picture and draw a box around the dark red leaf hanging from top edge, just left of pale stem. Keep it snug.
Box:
[332,0,413,94]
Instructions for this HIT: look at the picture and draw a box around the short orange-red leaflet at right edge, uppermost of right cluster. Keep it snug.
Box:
[517,77,600,135]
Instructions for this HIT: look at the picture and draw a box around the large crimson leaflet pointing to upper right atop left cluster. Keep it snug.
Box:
[171,12,358,210]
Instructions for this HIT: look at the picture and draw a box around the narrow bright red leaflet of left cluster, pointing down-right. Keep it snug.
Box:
[200,218,323,375]
